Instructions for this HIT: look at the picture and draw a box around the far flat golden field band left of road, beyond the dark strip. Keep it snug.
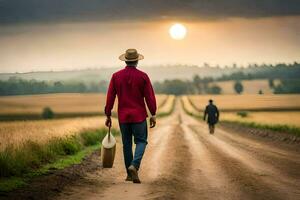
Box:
[0,93,167,115]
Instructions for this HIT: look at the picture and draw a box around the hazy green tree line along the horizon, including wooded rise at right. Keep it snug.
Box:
[0,62,300,96]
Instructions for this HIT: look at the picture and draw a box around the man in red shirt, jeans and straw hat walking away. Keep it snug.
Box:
[105,49,156,183]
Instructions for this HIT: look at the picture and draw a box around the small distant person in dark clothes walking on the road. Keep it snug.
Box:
[203,99,220,134]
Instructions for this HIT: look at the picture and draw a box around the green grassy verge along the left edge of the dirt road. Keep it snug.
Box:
[0,129,118,192]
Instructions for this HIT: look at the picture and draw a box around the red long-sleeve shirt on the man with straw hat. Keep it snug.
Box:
[105,66,156,123]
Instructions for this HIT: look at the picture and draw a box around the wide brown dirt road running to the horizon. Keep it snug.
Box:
[56,102,300,200]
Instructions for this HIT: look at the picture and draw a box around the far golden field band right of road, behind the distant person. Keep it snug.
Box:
[188,95,300,111]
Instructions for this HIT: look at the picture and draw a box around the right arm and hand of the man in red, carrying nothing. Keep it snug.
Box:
[144,75,157,128]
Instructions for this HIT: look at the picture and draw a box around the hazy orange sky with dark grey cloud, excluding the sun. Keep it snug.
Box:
[0,0,300,72]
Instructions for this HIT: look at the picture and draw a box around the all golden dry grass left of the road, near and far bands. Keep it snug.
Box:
[0,94,169,151]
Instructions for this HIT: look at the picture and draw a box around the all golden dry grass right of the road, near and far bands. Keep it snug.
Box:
[182,95,300,127]
